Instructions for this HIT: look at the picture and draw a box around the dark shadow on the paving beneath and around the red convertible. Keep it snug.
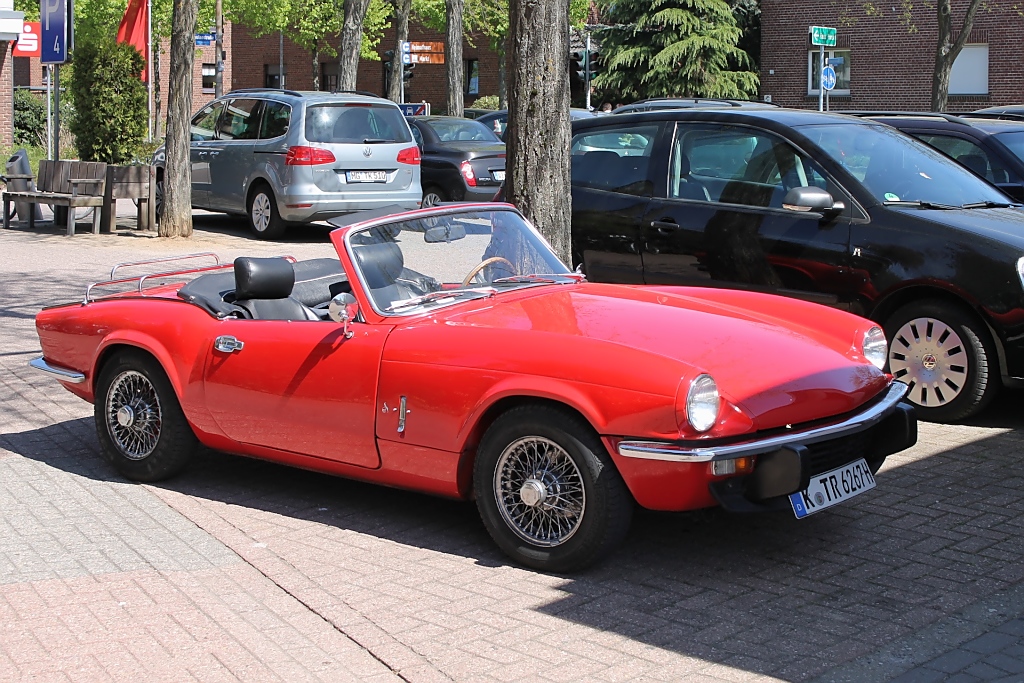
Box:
[8,411,1024,681]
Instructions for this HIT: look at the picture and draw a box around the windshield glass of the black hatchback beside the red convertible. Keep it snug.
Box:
[797,123,1010,206]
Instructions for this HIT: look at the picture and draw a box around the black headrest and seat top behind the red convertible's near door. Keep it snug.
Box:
[232,257,321,321]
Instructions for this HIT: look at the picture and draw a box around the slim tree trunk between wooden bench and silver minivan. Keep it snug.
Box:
[160,0,199,238]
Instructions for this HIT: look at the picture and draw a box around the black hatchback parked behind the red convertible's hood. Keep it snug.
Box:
[572,109,1024,421]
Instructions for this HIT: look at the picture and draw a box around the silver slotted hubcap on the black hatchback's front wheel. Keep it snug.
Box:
[889,317,970,408]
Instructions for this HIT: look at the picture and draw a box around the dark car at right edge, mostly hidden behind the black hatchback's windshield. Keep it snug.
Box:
[858,112,1024,201]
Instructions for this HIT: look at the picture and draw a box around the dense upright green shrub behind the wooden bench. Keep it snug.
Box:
[70,38,146,164]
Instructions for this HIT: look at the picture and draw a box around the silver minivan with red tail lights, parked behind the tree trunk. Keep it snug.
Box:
[153,88,422,240]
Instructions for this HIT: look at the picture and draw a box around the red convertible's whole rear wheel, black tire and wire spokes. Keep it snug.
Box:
[93,351,199,481]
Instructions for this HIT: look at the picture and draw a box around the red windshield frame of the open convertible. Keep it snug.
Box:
[335,202,583,319]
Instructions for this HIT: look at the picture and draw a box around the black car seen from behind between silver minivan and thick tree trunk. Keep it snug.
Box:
[409,116,505,207]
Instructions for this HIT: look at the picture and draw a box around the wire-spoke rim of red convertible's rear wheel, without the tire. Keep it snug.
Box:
[105,370,163,460]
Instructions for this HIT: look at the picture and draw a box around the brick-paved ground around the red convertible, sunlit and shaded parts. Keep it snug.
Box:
[0,210,1024,683]
